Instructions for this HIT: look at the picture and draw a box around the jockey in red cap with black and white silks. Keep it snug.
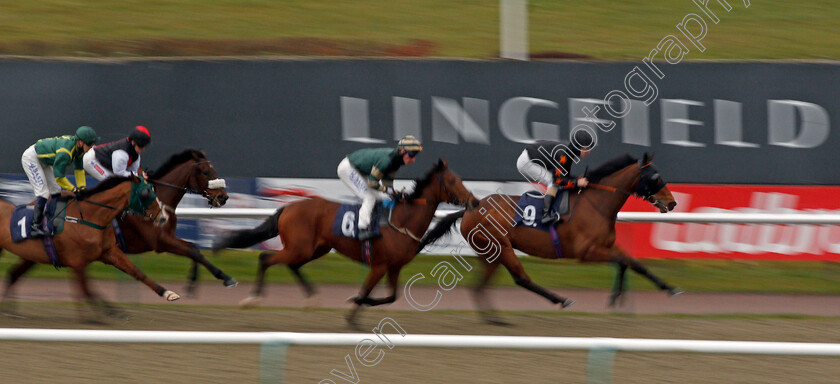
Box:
[83,126,152,180]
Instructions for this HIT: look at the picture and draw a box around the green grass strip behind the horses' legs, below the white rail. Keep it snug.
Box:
[0,251,840,294]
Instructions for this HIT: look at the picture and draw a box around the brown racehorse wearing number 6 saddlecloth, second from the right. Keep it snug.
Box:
[213,160,478,324]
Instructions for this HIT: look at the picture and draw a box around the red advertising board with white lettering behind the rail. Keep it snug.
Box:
[617,184,840,261]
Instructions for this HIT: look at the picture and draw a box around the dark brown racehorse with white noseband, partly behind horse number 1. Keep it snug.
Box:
[3,149,238,294]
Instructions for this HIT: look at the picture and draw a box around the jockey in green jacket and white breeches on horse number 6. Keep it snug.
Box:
[338,136,423,241]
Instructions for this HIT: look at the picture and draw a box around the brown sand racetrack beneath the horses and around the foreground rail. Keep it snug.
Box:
[0,280,840,384]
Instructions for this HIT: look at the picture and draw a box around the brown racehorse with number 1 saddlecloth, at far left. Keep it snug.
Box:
[0,176,180,315]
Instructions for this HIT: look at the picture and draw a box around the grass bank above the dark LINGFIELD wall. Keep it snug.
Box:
[0,0,840,61]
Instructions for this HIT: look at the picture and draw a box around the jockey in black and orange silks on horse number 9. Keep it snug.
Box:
[516,129,594,225]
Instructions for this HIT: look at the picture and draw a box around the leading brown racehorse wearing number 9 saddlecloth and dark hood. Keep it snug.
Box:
[418,154,682,322]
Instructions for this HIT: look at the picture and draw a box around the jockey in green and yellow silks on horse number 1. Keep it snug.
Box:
[20,126,99,237]
